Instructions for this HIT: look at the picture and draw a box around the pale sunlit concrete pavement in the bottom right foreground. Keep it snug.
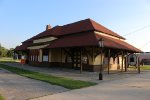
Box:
[32,71,150,100]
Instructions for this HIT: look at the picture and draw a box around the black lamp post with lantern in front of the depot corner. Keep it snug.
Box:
[99,38,104,80]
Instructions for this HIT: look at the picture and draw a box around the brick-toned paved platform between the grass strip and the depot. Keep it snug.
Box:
[4,63,141,83]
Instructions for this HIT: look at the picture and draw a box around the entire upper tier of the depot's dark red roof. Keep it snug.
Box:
[24,19,125,42]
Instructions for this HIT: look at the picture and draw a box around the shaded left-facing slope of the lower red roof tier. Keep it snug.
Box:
[46,32,98,48]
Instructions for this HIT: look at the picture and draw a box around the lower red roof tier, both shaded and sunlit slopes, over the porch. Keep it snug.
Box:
[46,32,142,52]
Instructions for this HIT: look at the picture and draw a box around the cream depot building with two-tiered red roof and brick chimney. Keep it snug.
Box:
[15,19,142,71]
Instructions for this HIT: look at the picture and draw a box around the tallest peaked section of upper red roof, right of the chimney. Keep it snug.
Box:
[52,19,125,39]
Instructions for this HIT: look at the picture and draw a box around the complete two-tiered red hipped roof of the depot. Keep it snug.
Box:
[16,19,141,52]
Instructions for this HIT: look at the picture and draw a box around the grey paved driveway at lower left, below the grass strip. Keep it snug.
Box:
[0,69,68,100]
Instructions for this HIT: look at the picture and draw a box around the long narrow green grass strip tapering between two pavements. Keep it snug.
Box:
[0,64,96,89]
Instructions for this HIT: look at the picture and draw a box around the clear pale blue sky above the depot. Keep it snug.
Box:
[0,0,150,52]
